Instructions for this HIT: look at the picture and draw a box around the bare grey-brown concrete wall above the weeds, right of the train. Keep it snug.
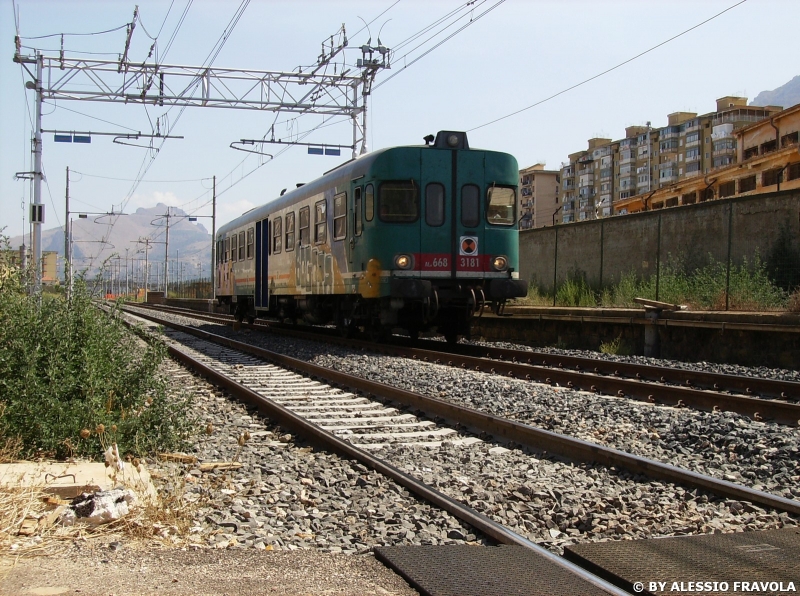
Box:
[519,190,800,293]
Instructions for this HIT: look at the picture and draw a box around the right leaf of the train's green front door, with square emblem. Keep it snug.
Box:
[451,151,486,279]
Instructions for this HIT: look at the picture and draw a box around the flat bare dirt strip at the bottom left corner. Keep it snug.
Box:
[0,541,417,596]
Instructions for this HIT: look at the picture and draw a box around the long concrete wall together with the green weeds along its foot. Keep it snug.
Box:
[520,191,800,311]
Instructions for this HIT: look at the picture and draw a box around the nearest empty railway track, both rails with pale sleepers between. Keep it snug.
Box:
[119,304,800,593]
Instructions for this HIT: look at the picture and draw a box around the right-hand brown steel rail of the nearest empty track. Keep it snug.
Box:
[122,313,800,515]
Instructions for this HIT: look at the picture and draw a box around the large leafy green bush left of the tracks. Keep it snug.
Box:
[0,244,193,457]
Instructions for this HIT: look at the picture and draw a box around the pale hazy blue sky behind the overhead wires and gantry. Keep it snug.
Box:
[0,0,800,246]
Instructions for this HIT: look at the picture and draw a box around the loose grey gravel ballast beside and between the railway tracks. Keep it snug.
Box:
[117,308,800,554]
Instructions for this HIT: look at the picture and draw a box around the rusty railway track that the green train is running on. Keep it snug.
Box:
[131,308,800,426]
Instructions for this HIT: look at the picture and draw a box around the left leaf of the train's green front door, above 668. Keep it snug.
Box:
[418,151,453,278]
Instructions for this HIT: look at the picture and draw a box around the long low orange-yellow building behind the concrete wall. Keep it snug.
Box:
[615,104,800,214]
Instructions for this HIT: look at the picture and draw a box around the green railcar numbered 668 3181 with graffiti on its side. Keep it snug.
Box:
[215,131,527,342]
